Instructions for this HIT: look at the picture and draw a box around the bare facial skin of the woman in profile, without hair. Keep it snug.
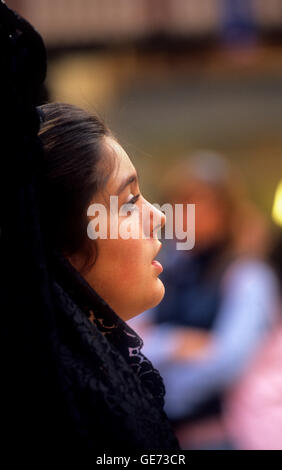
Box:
[69,137,165,320]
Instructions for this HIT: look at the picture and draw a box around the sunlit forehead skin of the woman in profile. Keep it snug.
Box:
[104,136,136,193]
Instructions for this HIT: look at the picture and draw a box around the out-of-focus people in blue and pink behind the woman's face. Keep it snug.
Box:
[130,152,282,449]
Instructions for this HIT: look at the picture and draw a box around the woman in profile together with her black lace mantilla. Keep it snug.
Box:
[0,2,179,458]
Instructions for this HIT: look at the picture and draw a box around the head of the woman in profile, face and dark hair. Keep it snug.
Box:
[39,103,165,320]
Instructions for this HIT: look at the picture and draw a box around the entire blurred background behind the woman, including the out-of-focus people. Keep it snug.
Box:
[7,0,282,449]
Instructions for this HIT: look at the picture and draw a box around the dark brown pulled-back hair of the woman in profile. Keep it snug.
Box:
[38,103,114,271]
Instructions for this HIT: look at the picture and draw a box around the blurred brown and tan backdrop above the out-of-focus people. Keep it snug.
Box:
[7,0,282,209]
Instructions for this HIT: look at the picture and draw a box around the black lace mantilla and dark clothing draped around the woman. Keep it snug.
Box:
[0,2,179,458]
